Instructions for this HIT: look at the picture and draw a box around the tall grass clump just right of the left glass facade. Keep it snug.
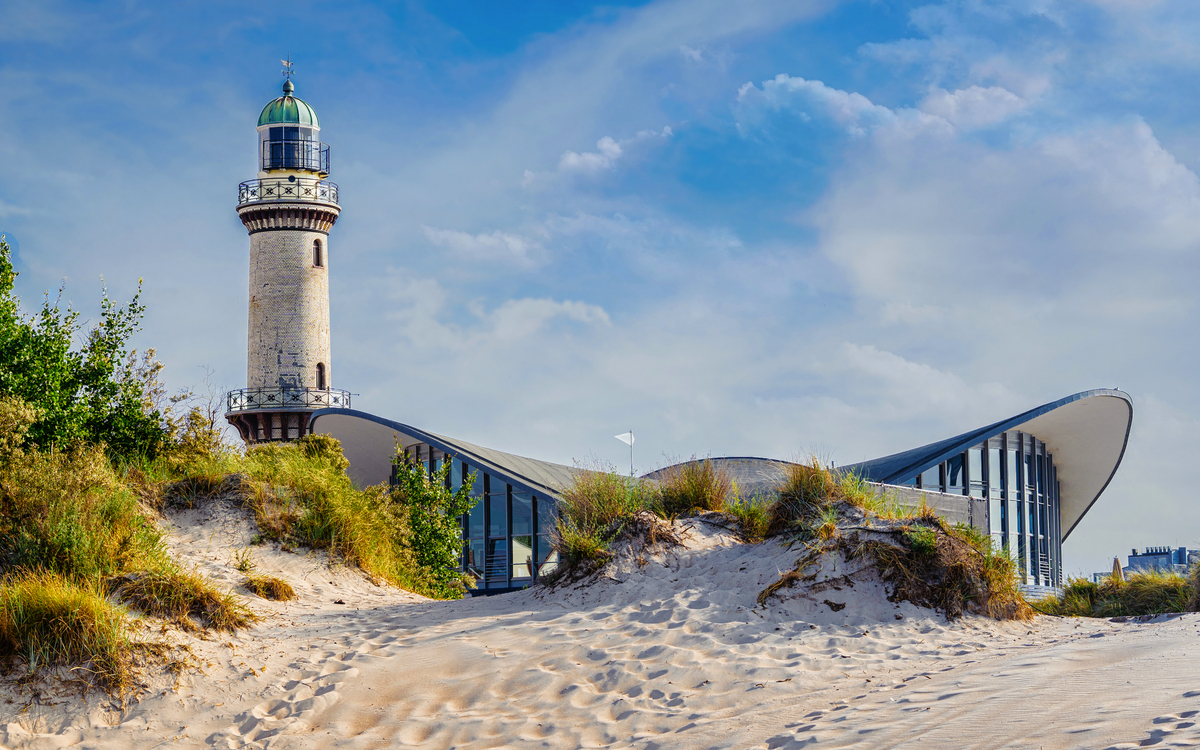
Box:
[552,468,660,568]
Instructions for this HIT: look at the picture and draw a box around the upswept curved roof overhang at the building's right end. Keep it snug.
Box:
[844,389,1133,539]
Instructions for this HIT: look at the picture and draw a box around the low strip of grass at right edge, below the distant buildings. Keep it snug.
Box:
[1033,566,1200,617]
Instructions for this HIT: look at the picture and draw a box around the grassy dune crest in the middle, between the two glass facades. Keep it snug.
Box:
[547,458,1032,619]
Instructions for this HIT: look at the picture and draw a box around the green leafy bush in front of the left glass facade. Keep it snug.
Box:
[391,456,478,598]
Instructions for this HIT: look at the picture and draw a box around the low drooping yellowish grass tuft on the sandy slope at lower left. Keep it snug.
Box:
[109,571,259,631]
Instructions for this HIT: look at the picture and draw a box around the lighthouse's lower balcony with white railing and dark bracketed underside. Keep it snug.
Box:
[226,388,350,443]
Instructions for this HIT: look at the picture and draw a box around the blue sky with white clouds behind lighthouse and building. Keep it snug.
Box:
[0,0,1200,572]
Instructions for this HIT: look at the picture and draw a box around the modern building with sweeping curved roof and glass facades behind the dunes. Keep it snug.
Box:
[312,389,1133,592]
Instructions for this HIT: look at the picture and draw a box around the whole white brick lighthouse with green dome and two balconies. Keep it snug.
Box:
[226,62,350,444]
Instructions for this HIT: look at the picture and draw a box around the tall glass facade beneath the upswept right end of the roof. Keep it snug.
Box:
[900,432,1062,586]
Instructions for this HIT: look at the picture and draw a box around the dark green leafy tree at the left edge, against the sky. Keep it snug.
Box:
[0,238,167,457]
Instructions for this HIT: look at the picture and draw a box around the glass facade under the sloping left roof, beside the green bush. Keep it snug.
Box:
[404,444,558,592]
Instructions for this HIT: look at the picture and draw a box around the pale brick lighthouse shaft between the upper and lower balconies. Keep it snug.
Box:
[246,229,332,388]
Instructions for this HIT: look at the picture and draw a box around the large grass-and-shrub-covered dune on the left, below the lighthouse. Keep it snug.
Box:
[0,397,470,692]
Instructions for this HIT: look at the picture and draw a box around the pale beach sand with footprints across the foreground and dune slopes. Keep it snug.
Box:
[0,502,1200,750]
